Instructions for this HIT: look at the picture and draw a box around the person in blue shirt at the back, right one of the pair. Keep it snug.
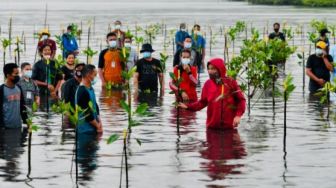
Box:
[191,24,206,73]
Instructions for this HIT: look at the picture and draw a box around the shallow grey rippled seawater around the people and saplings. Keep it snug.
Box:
[0,0,336,188]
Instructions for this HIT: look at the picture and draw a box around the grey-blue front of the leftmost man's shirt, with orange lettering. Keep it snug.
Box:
[2,85,22,128]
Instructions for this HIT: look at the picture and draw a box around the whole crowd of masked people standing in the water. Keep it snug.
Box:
[0,21,336,137]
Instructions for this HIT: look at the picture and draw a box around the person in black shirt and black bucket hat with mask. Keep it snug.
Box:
[134,44,164,97]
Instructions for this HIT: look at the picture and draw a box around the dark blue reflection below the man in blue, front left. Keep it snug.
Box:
[77,134,99,184]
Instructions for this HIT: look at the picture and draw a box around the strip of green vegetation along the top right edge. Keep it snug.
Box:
[233,0,336,7]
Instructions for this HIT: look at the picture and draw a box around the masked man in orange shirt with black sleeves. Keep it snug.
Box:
[98,32,125,87]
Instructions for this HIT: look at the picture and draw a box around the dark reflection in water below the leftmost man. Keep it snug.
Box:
[0,129,27,181]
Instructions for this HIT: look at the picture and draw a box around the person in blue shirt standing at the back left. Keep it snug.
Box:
[62,25,79,58]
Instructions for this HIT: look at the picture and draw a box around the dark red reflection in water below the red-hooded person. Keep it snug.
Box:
[200,130,246,180]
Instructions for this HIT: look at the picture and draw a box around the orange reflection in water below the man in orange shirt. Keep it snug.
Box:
[100,89,125,112]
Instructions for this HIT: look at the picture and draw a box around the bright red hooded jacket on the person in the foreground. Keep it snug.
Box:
[188,58,246,129]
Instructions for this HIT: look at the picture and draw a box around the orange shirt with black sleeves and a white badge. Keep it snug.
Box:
[98,49,125,84]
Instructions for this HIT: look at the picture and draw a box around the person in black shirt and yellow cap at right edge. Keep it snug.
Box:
[306,41,333,93]
